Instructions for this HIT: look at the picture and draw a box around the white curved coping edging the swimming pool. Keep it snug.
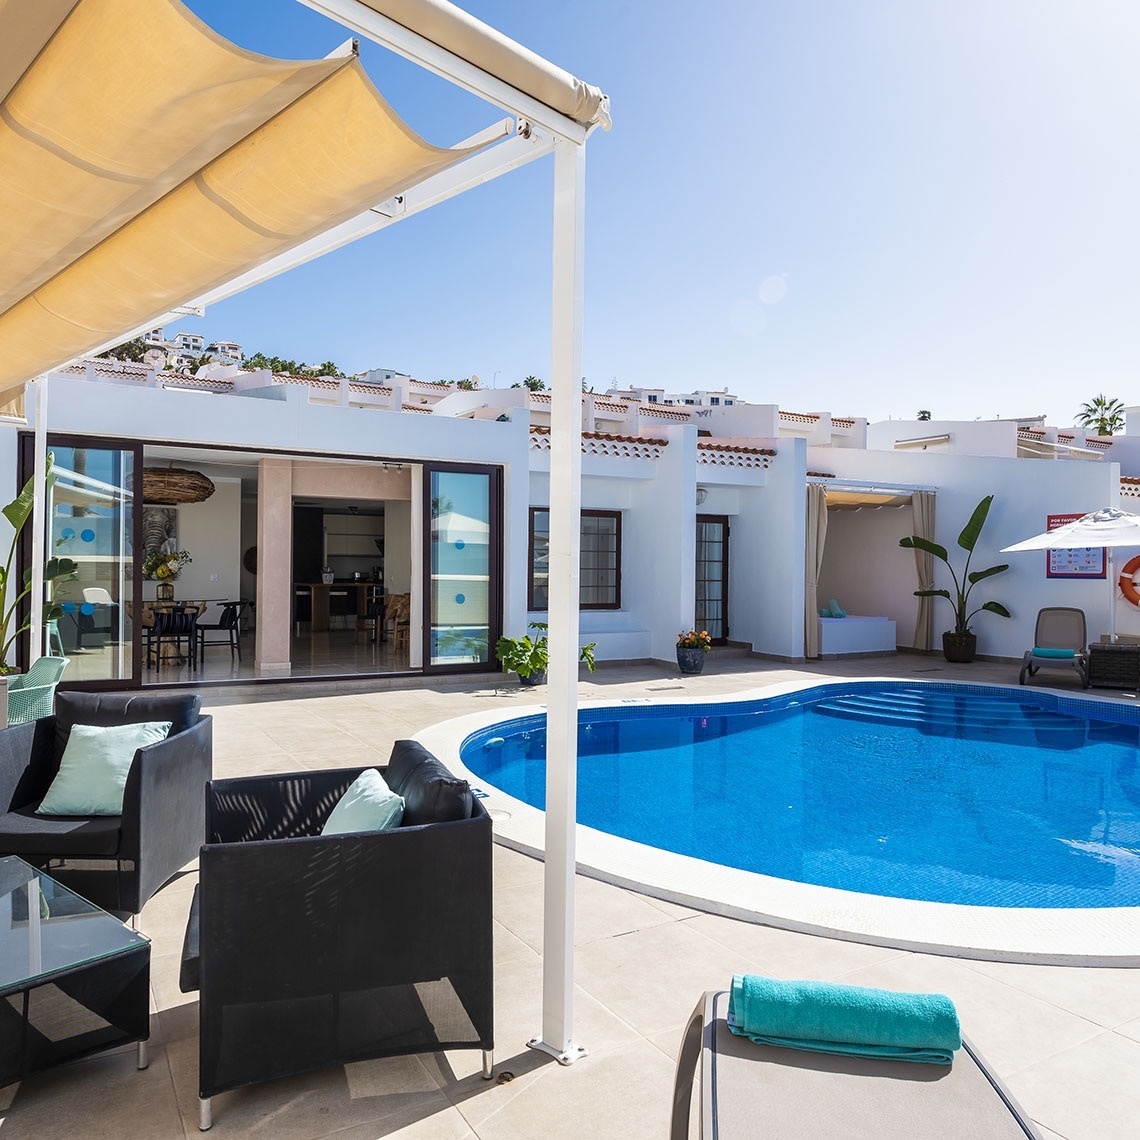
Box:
[415,677,1140,967]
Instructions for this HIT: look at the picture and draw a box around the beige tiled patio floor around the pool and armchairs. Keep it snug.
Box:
[0,654,1140,1140]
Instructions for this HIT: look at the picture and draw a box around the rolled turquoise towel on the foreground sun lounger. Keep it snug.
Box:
[728,974,962,1065]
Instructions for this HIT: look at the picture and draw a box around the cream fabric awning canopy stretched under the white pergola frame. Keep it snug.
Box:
[0,0,485,402]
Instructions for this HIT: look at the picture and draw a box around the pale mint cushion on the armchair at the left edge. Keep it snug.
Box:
[35,720,171,815]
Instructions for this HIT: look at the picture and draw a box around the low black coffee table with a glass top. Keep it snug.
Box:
[0,855,150,1085]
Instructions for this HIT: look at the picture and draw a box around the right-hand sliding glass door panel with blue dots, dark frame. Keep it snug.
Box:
[424,464,503,670]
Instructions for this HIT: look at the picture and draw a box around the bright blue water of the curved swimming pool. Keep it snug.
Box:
[462,683,1140,907]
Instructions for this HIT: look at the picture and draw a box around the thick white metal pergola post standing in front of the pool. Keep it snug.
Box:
[528,141,586,1065]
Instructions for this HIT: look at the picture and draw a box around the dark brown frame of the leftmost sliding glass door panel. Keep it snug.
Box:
[16,431,143,691]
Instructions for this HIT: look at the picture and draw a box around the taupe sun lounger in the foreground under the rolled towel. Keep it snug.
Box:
[669,991,1041,1140]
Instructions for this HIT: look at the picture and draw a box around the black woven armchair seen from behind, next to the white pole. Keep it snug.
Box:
[180,740,494,1130]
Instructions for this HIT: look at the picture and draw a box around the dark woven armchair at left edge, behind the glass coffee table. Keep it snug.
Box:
[0,692,213,914]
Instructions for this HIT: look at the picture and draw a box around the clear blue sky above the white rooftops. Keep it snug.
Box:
[180,0,1140,425]
